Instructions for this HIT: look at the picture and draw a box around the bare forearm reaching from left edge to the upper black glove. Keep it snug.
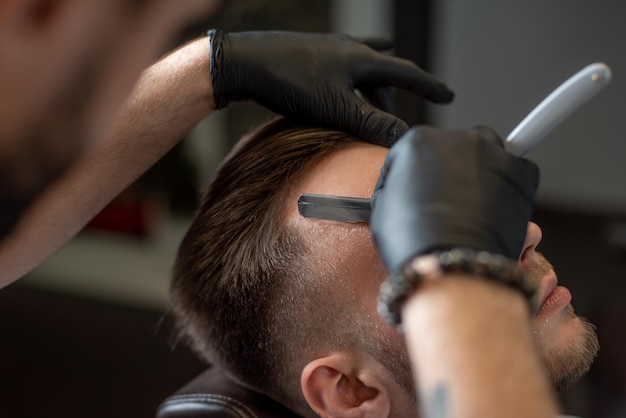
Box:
[0,39,215,288]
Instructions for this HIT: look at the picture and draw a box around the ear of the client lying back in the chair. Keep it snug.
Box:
[300,352,391,418]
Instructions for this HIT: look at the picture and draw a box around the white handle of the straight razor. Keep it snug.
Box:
[504,63,611,156]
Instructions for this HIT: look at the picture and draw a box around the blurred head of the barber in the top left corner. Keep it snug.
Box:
[0,0,218,233]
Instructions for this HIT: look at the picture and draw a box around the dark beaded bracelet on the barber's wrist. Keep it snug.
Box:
[378,248,538,330]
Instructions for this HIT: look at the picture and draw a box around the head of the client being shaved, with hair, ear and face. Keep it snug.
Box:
[172,116,596,416]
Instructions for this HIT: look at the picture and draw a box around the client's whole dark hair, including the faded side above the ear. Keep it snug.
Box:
[171,118,413,413]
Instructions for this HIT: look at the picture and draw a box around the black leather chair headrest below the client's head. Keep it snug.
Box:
[157,367,301,418]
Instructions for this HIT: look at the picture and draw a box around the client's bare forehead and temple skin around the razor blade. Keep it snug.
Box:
[288,142,389,296]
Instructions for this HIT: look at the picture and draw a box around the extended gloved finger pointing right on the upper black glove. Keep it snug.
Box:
[353,53,454,103]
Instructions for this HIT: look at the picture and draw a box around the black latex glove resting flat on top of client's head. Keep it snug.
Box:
[209,30,454,146]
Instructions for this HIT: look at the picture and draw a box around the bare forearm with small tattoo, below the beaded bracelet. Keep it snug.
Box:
[402,277,557,418]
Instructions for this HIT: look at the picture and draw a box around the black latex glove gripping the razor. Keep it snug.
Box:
[370,127,539,273]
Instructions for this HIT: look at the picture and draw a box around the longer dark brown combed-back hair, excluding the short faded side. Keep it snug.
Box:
[171,118,356,398]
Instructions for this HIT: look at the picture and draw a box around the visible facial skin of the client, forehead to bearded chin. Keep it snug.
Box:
[290,143,597,411]
